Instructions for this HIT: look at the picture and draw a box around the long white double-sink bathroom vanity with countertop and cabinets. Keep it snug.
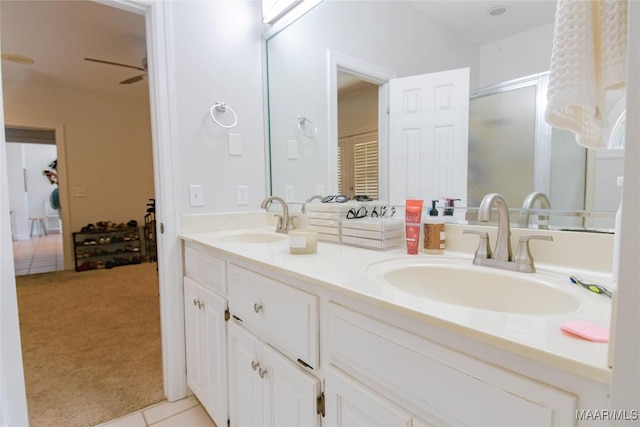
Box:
[181,212,612,426]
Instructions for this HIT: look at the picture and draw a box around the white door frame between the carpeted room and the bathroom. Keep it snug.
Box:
[100,0,187,401]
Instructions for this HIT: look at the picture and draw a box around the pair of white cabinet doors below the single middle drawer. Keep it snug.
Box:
[229,319,320,427]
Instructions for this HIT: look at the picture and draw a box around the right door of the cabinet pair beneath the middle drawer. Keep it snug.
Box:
[259,345,320,427]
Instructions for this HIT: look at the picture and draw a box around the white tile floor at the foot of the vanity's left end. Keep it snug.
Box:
[99,396,216,427]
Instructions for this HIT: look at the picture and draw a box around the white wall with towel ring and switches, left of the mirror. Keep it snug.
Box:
[167,1,266,214]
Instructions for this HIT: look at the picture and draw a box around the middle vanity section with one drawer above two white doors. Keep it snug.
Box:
[228,264,321,427]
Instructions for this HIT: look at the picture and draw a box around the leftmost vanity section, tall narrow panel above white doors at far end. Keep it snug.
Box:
[184,246,228,425]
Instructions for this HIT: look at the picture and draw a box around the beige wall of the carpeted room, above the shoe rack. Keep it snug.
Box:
[3,79,154,234]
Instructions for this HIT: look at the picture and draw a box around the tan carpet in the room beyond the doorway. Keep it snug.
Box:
[16,263,164,427]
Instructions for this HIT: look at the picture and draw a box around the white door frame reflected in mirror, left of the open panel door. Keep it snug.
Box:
[327,49,396,200]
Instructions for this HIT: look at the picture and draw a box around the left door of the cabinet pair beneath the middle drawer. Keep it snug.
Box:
[229,321,264,427]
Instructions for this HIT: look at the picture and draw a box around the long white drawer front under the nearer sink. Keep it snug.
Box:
[328,303,577,426]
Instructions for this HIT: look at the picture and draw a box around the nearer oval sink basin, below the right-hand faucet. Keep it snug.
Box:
[368,262,580,315]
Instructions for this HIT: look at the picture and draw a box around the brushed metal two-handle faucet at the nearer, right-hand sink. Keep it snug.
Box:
[463,193,553,273]
